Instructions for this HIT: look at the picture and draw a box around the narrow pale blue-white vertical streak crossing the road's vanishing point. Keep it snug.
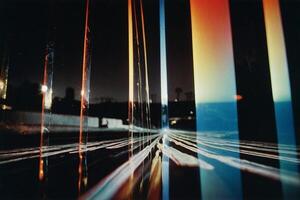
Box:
[159,0,169,200]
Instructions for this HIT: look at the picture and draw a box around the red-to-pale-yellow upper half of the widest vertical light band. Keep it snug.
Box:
[190,0,236,103]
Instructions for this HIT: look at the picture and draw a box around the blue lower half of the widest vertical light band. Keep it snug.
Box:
[196,103,242,199]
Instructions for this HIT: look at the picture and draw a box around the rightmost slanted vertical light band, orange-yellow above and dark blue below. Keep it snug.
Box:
[263,0,298,198]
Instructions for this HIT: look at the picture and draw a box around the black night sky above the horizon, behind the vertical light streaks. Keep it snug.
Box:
[0,0,299,102]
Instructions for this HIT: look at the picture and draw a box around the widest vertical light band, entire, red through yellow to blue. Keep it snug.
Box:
[190,0,242,199]
